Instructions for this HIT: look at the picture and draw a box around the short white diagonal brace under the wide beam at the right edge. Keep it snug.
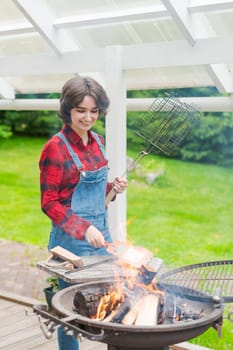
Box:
[206,64,233,93]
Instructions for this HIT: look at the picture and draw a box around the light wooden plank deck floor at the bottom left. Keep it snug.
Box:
[0,298,107,350]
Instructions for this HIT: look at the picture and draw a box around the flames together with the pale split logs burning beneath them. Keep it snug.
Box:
[87,241,163,324]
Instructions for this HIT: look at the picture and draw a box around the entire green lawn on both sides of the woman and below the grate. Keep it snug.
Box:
[0,137,233,350]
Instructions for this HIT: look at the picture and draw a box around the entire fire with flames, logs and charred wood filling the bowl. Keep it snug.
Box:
[74,242,206,326]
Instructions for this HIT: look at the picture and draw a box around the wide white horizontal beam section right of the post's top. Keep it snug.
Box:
[123,36,233,69]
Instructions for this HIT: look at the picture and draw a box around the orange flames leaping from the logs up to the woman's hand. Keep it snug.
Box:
[92,241,163,321]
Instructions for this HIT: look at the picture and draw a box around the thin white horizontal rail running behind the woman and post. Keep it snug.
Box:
[0,96,233,112]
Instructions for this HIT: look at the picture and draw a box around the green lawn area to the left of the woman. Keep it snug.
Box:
[0,137,50,246]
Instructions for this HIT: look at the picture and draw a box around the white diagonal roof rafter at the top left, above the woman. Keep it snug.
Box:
[13,0,77,55]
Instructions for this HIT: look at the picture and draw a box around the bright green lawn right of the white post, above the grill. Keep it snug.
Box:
[128,157,233,265]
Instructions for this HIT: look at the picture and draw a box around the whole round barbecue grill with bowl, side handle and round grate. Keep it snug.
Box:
[34,260,233,350]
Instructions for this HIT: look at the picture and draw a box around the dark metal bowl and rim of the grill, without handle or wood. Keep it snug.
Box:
[52,280,223,350]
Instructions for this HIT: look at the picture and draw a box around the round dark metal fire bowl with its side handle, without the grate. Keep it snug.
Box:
[34,280,223,350]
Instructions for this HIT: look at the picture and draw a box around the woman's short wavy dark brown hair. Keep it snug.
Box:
[58,76,109,124]
